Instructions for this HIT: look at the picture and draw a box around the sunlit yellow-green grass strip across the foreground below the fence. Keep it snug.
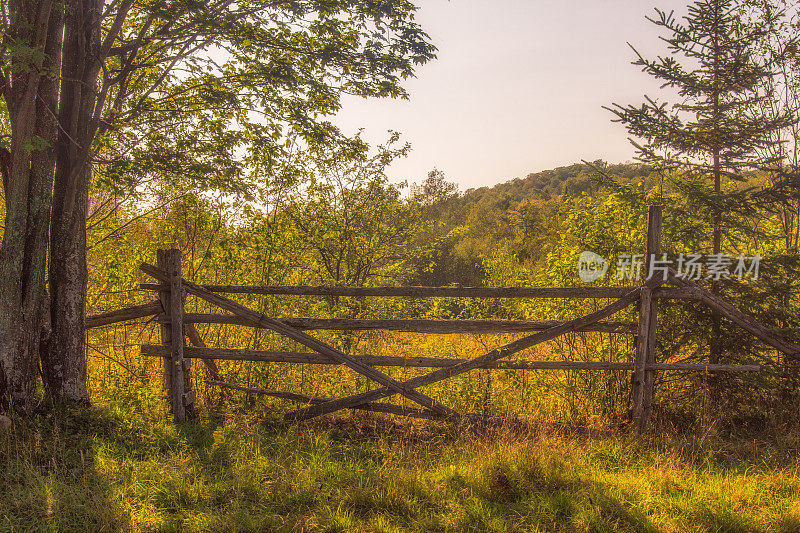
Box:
[0,390,800,532]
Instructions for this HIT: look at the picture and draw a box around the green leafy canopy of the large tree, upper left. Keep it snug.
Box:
[85,0,435,200]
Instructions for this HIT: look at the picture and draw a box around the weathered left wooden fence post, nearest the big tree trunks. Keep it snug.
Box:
[157,249,194,423]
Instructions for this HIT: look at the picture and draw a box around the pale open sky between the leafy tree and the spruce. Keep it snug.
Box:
[334,0,686,190]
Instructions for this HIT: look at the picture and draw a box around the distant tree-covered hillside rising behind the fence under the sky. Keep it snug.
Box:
[408,160,660,285]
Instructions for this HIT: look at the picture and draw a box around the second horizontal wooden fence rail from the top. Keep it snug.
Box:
[178,313,636,334]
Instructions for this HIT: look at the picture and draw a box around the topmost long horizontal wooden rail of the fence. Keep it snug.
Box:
[139,283,697,299]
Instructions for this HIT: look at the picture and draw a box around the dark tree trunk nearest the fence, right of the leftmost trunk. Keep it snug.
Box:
[42,0,103,401]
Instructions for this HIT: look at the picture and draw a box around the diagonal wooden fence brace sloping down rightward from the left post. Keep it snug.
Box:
[140,263,460,418]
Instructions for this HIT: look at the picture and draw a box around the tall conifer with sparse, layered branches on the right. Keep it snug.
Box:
[606,0,791,374]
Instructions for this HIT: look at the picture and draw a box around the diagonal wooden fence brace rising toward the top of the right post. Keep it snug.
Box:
[284,280,657,422]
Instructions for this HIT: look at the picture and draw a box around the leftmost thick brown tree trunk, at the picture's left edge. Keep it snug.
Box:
[0,0,62,409]
